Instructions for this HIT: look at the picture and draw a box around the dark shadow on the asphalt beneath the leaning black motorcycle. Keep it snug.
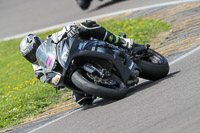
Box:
[83,71,180,110]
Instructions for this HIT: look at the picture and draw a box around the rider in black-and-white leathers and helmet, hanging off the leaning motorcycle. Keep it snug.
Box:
[19,20,133,105]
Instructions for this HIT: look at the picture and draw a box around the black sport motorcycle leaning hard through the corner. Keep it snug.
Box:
[36,34,169,100]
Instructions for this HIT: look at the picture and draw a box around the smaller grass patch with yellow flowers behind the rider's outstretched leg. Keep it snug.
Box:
[100,18,170,44]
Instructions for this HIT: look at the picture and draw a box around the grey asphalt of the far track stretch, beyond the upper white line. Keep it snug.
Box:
[0,0,177,40]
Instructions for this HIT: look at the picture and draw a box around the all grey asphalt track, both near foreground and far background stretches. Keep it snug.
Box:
[0,0,200,133]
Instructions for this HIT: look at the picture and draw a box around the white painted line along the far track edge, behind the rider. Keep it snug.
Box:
[0,0,200,42]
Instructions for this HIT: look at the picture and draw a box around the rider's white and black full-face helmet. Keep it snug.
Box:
[19,34,43,64]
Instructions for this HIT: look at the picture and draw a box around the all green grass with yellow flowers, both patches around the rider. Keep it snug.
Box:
[0,18,170,129]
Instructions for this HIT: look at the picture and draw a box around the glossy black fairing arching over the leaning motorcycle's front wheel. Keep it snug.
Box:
[57,38,136,83]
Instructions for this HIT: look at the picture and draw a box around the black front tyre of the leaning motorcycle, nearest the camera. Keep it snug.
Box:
[71,70,128,100]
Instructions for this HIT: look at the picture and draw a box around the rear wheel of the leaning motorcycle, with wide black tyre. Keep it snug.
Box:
[134,49,169,80]
